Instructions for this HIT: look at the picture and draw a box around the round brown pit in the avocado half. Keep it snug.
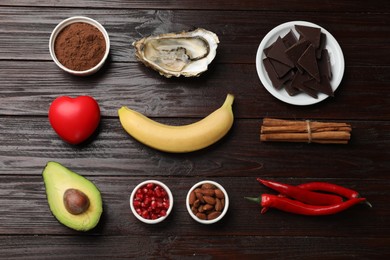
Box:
[64,189,90,215]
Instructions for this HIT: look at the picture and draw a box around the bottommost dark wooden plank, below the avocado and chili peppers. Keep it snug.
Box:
[0,234,390,259]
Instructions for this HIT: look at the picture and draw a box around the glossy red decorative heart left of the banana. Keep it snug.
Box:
[49,96,100,144]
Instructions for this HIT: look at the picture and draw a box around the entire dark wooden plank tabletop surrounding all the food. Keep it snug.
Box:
[0,0,390,259]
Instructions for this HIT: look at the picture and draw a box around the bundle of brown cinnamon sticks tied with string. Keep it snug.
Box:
[260,118,352,144]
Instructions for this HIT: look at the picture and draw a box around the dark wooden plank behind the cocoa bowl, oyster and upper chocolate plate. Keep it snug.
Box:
[0,7,390,66]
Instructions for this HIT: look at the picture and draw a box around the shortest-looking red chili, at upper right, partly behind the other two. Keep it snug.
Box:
[297,182,360,199]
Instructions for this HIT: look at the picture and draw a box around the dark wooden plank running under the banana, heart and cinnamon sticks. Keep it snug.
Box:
[0,117,390,180]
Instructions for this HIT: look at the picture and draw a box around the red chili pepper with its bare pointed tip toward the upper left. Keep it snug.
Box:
[257,178,343,205]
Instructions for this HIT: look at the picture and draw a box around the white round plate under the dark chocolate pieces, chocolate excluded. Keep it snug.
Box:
[256,21,345,106]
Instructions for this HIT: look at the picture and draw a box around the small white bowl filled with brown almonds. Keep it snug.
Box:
[186,180,229,224]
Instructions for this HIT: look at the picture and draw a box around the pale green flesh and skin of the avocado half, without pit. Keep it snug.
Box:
[42,162,103,231]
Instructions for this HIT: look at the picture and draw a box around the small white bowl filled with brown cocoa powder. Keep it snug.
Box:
[49,16,110,76]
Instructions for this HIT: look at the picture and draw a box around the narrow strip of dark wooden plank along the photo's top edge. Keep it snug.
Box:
[0,0,390,12]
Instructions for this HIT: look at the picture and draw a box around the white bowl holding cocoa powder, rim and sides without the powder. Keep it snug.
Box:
[49,16,110,76]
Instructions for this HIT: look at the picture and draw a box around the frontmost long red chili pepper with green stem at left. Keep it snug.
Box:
[246,194,366,216]
